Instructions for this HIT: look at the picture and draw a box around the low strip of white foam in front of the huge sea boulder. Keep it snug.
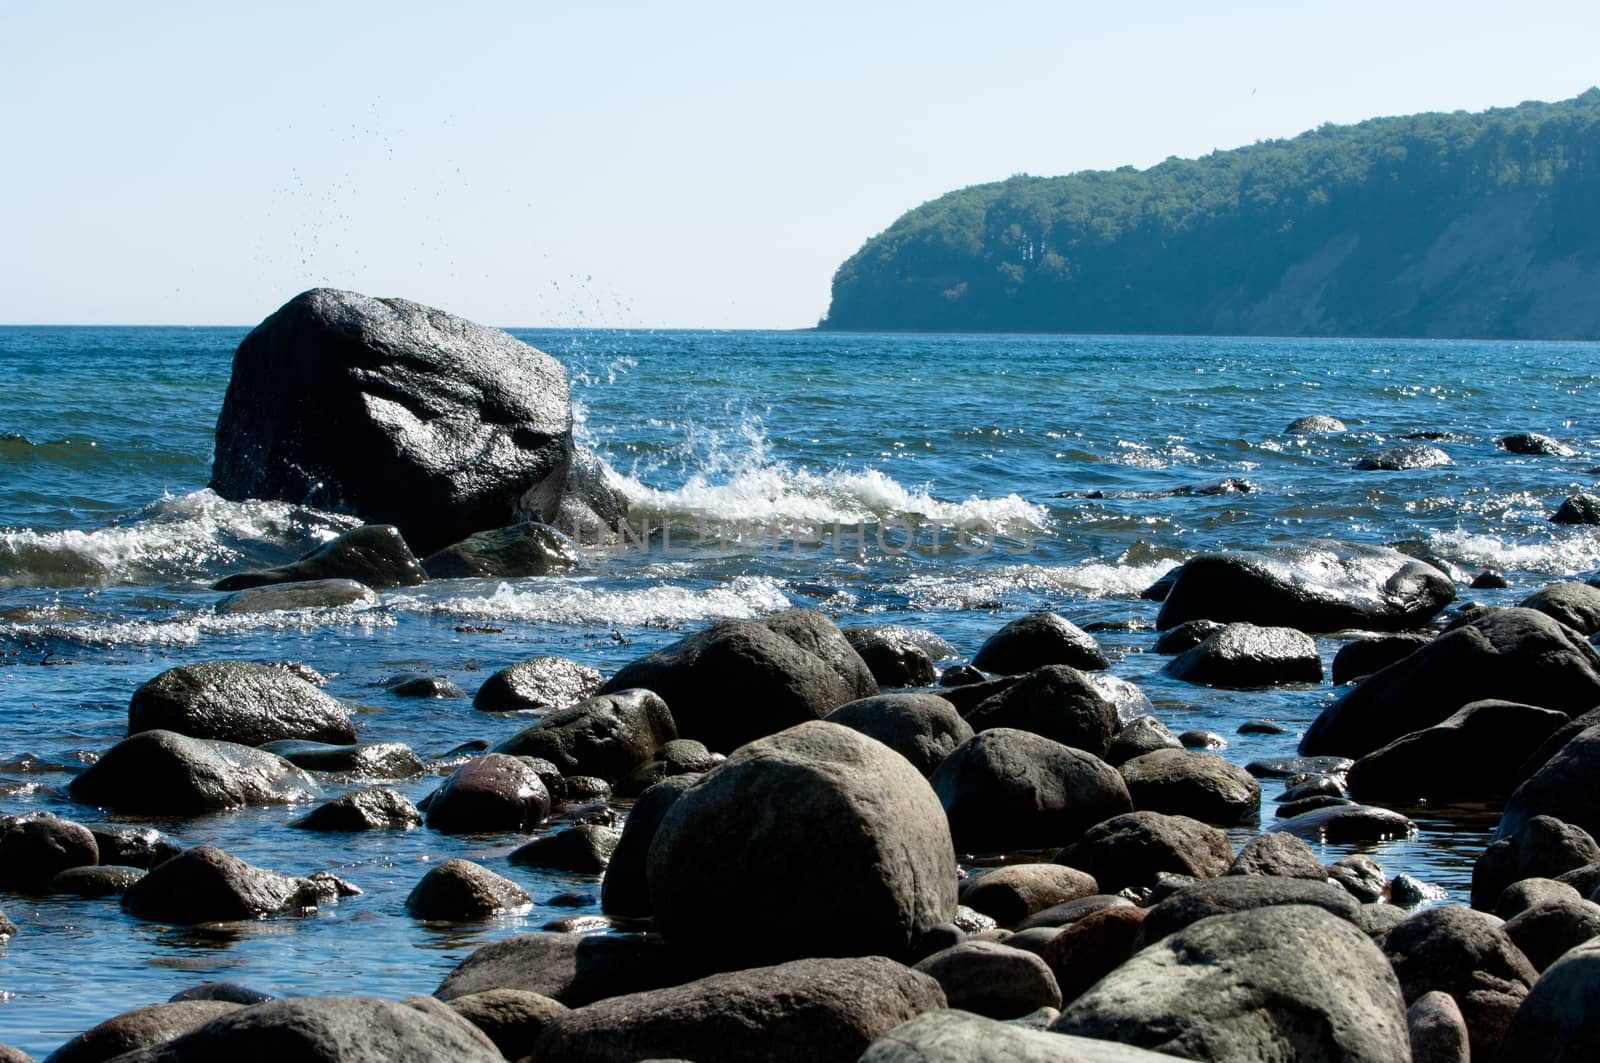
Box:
[398,576,792,626]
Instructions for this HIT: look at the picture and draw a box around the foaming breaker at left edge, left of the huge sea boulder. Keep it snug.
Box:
[0,490,358,588]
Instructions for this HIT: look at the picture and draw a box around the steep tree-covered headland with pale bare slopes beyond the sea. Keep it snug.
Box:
[822,90,1600,339]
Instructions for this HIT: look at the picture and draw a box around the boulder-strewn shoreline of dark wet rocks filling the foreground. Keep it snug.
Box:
[0,296,1600,1063]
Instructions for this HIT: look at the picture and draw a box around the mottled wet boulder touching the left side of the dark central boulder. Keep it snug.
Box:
[494,690,678,781]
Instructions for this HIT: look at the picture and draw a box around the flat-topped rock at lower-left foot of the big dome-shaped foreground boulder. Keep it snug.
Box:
[434,932,693,1007]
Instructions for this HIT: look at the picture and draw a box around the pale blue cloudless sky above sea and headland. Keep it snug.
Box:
[0,0,1600,328]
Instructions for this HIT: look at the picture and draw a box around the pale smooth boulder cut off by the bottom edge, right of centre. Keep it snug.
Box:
[861,1009,1171,1063]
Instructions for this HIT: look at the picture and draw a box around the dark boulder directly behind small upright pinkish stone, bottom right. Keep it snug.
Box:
[1382,905,1539,1060]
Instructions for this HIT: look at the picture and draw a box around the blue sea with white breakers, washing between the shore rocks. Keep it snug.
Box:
[0,327,1600,1057]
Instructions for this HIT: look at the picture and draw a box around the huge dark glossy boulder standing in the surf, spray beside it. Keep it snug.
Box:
[211,288,573,551]
